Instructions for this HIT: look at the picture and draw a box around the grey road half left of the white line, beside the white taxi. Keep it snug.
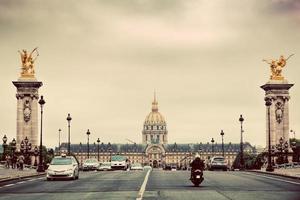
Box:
[0,171,146,200]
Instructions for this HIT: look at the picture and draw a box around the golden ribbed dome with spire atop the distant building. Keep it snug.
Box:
[144,94,166,125]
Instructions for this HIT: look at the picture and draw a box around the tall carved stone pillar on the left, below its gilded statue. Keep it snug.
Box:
[13,78,43,149]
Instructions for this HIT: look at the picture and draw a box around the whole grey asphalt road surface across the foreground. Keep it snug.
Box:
[0,170,300,200]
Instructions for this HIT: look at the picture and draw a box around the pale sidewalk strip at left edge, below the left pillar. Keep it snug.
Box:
[0,165,45,182]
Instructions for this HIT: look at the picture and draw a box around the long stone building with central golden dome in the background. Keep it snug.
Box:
[56,97,255,167]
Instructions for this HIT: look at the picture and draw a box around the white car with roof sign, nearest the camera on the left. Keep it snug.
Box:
[46,155,79,180]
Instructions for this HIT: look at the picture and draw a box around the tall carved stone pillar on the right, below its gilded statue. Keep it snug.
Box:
[261,80,294,148]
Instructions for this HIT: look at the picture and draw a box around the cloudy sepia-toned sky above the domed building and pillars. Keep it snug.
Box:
[0,0,300,147]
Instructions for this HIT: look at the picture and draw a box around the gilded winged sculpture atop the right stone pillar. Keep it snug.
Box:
[263,54,294,80]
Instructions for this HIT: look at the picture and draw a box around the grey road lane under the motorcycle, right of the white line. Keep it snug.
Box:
[143,170,300,200]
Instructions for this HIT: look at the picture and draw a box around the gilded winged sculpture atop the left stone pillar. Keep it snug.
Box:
[19,47,39,78]
